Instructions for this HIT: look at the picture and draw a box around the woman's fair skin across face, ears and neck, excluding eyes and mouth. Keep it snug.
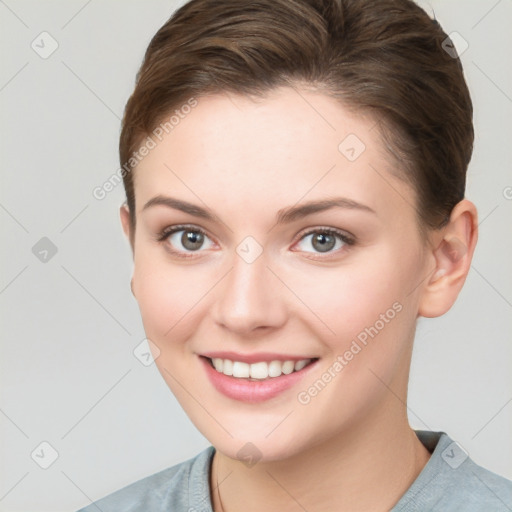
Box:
[120,88,477,512]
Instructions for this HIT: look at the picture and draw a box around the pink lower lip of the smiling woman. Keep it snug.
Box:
[200,356,318,403]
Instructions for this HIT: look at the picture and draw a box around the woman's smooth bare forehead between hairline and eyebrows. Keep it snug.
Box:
[135,88,412,226]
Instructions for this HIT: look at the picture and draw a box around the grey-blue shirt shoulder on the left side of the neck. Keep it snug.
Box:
[77,446,215,512]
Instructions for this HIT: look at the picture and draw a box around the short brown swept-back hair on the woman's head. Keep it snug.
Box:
[119,0,474,232]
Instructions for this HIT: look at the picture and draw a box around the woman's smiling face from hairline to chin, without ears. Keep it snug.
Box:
[124,88,429,460]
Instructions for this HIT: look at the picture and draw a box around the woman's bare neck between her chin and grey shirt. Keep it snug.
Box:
[211,398,430,512]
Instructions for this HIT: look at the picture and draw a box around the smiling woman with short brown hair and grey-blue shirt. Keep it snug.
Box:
[76,0,512,512]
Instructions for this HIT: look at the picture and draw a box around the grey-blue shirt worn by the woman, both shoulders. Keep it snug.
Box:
[77,430,512,512]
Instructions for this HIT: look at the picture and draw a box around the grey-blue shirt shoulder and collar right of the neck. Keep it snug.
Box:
[393,431,512,512]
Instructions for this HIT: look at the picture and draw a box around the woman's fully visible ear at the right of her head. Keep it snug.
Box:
[418,199,478,318]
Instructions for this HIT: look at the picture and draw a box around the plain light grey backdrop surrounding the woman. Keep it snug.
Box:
[0,0,512,512]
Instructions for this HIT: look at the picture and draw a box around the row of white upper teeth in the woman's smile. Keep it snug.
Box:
[212,357,312,380]
